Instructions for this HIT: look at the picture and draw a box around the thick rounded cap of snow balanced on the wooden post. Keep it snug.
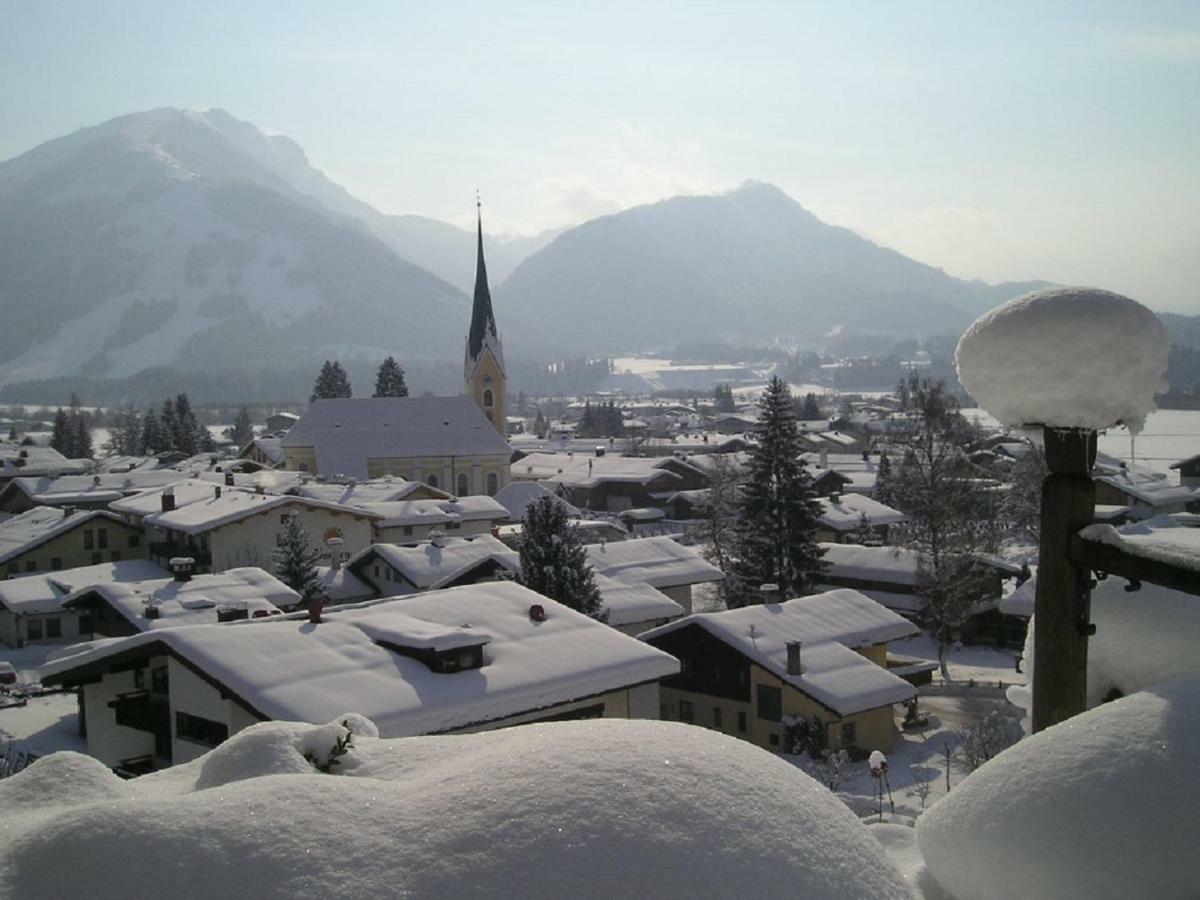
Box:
[955,288,1170,433]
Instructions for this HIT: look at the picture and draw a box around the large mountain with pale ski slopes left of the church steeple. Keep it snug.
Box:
[0,109,492,382]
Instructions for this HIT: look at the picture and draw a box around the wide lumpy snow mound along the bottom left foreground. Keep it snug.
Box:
[0,720,908,900]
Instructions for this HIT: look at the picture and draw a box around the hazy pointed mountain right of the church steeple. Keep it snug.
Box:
[496,181,1044,353]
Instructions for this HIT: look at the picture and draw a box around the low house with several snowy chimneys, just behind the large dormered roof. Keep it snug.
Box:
[62,563,300,637]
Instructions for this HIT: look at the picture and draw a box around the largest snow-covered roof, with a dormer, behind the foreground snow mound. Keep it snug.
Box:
[42,582,679,737]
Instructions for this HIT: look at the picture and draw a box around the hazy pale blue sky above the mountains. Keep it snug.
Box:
[7,0,1200,313]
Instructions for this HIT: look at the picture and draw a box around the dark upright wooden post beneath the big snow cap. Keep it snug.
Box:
[1033,426,1096,731]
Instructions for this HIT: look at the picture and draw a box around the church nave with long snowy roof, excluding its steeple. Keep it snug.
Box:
[282,396,512,497]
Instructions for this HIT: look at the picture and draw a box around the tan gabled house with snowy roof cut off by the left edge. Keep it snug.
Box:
[0,506,146,577]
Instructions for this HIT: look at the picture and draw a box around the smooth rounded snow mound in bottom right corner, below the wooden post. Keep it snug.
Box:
[917,678,1200,900]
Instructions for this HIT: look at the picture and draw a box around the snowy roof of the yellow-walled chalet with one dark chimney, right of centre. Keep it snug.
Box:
[640,588,919,715]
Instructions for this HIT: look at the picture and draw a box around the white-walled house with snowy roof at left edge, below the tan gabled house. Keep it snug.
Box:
[0,559,168,647]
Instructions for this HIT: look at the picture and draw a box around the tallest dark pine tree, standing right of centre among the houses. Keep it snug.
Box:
[734,377,823,602]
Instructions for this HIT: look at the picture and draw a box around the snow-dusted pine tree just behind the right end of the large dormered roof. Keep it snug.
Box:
[520,497,607,622]
